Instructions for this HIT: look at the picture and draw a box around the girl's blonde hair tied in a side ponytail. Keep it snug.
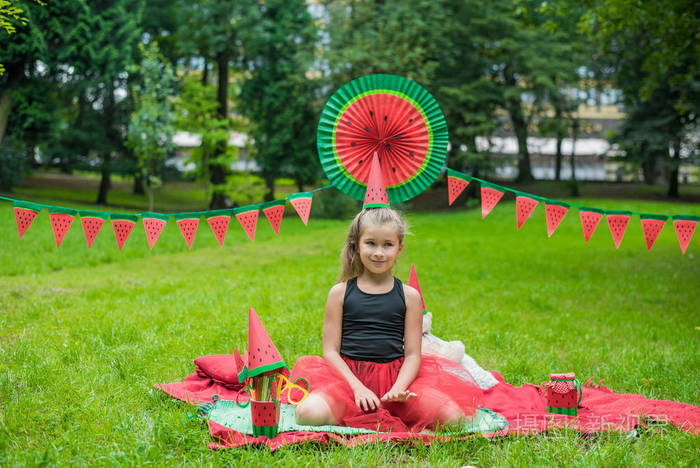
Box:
[338,208,408,283]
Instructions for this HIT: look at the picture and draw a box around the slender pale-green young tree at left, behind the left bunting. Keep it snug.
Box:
[127,42,176,211]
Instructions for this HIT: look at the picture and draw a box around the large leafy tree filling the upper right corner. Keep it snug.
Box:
[581,0,700,197]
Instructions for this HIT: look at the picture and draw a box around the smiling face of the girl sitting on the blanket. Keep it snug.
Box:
[359,224,403,275]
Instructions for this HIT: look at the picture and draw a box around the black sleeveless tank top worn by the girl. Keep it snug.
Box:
[340,278,406,362]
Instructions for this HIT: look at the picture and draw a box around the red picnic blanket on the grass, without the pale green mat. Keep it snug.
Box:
[155,354,700,450]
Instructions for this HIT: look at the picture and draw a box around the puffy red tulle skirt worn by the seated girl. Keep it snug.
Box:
[292,354,483,432]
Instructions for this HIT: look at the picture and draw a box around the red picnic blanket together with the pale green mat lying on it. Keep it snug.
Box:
[155,355,700,451]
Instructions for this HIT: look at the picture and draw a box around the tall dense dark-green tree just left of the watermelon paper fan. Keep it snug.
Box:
[240,0,319,200]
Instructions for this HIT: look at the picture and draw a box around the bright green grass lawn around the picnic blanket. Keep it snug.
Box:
[0,188,700,466]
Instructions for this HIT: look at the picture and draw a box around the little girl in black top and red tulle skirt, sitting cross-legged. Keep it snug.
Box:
[292,208,482,431]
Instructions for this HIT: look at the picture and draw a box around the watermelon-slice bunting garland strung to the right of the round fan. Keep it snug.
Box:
[444,167,700,254]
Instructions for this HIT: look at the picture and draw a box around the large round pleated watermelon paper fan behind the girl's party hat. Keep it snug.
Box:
[316,75,447,204]
